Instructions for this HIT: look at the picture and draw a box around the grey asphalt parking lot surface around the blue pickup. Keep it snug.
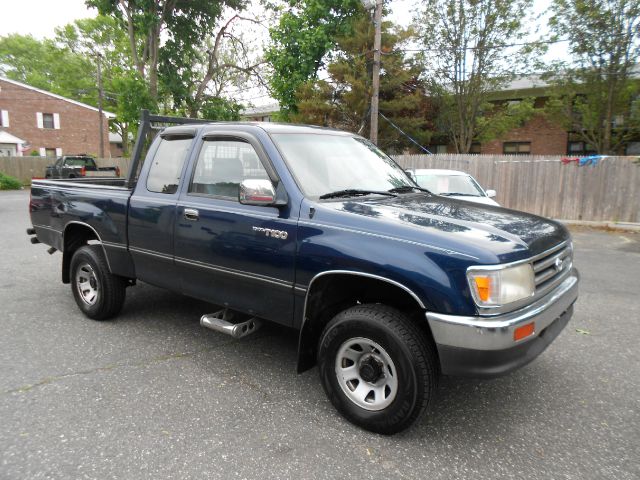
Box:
[0,191,640,480]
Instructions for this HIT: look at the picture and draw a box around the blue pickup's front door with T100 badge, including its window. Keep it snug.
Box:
[175,132,297,325]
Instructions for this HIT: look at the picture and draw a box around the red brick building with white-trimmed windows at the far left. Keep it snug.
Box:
[0,77,115,157]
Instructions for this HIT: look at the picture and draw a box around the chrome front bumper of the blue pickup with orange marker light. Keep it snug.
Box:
[426,269,580,377]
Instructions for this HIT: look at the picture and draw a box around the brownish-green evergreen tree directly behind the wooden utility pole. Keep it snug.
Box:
[291,15,432,152]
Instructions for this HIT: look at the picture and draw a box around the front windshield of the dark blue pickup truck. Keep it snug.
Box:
[272,133,413,197]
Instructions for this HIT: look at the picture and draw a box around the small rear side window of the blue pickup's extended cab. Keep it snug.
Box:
[147,138,192,194]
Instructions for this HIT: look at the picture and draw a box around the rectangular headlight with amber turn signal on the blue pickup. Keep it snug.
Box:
[467,263,535,307]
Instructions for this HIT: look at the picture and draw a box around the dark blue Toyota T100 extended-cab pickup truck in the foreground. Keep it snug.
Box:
[28,114,579,434]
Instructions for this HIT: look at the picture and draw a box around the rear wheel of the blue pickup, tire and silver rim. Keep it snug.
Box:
[70,245,127,320]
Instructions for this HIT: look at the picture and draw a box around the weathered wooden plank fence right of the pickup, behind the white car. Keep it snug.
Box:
[394,154,640,223]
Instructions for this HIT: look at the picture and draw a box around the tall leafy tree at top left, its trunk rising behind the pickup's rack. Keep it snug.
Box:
[86,0,245,99]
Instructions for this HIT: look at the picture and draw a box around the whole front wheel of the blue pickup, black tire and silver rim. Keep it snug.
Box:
[318,304,439,435]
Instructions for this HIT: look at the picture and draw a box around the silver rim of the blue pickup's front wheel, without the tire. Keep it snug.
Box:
[335,337,398,411]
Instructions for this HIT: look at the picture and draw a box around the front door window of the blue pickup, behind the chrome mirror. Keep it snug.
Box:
[189,140,269,200]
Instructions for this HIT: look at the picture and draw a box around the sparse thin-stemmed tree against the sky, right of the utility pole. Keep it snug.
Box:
[417,0,532,153]
